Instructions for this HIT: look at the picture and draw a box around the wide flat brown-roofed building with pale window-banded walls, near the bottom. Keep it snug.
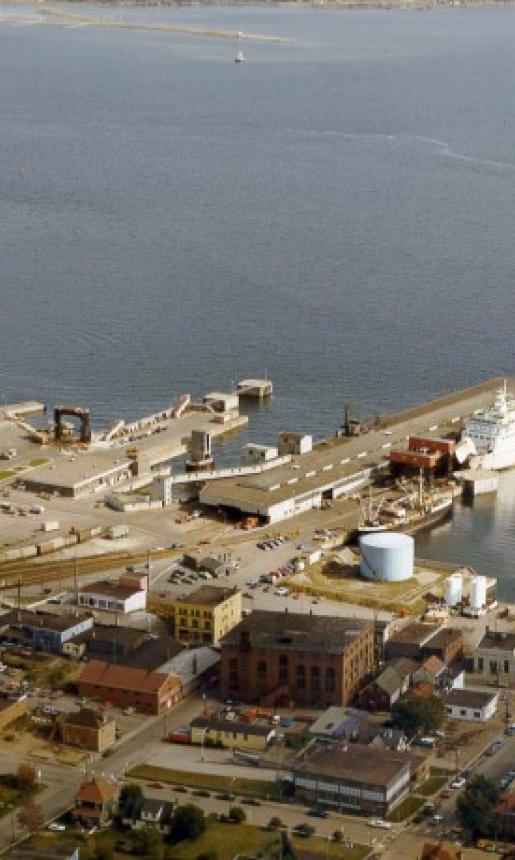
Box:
[292,740,411,816]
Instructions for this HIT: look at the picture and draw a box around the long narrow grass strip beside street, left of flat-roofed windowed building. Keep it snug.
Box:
[128,764,281,800]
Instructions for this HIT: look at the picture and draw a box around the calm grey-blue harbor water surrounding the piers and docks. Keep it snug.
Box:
[0,4,515,598]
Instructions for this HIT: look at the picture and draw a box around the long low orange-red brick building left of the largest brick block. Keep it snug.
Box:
[77,660,182,714]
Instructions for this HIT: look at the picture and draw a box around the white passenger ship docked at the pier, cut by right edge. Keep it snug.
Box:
[462,382,515,470]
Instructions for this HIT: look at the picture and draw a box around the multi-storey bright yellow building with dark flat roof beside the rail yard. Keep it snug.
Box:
[171,585,241,645]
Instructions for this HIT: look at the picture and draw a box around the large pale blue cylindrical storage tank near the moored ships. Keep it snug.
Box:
[359,532,415,582]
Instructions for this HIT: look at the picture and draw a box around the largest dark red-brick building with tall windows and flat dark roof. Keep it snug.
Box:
[220,611,374,707]
